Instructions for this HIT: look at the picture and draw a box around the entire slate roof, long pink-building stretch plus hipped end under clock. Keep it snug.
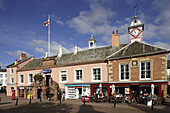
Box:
[19,42,169,71]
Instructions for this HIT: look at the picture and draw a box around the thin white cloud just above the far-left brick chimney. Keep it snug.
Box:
[6,50,32,58]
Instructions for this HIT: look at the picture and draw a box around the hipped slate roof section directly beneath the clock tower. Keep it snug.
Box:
[106,41,169,59]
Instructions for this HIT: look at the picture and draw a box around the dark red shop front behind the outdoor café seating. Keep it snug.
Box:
[90,82,167,100]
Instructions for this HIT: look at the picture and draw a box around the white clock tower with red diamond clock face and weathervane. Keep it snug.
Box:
[128,5,144,43]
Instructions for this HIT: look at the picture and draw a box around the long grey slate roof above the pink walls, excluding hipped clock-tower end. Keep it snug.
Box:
[20,44,126,71]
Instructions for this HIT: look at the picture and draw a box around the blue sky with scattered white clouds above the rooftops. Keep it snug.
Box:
[0,0,170,68]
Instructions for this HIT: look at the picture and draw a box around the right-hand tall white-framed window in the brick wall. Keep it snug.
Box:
[141,61,151,79]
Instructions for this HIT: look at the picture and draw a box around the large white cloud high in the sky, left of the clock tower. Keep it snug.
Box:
[67,2,115,35]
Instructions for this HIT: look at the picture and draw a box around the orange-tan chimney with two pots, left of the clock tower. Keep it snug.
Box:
[112,30,119,47]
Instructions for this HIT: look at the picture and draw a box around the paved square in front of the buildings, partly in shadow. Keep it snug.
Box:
[0,94,170,113]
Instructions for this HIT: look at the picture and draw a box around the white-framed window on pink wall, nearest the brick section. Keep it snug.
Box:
[92,68,101,81]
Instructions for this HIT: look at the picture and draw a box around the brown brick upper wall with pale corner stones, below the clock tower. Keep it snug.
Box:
[108,54,167,82]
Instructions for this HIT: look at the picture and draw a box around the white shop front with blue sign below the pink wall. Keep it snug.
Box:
[65,84,90,99]
